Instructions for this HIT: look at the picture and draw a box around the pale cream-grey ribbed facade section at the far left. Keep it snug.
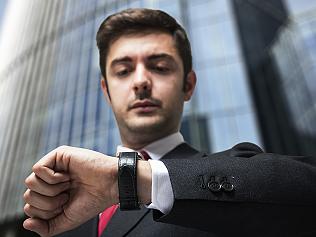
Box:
[0,1,66,226]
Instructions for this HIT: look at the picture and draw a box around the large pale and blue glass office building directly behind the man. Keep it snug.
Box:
[0,0,314,236]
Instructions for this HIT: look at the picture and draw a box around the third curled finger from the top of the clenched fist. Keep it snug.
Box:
[23,189,69,211]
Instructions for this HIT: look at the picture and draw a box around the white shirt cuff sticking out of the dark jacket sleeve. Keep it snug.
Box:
[145,160,174,214]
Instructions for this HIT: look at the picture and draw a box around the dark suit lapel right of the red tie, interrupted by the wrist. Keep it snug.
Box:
[101,143,199,237]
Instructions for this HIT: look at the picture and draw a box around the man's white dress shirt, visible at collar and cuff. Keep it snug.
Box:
[117,132,184,214]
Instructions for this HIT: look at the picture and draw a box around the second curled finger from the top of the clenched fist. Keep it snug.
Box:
[25,173,70,197]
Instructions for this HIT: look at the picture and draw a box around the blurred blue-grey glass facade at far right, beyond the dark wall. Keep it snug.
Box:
[271,0,316,154]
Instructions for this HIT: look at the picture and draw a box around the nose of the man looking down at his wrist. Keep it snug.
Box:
[133,65,152,94]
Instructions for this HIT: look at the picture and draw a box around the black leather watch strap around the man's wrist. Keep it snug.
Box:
[118,152,140,211]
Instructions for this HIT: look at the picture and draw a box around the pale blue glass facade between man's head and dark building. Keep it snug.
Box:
[185,0,260,151]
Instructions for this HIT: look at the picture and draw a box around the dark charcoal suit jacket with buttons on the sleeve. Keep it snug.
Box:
[59,143,316,237]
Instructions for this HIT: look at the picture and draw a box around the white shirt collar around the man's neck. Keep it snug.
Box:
[116,132,184,160]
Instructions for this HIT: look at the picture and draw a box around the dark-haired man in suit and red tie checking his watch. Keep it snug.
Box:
[24,9,316,236]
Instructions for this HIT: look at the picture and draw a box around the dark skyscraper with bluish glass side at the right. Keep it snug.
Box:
[234,0,316,155]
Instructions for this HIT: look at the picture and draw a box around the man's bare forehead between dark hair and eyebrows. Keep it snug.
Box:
[106,32,181,65]
